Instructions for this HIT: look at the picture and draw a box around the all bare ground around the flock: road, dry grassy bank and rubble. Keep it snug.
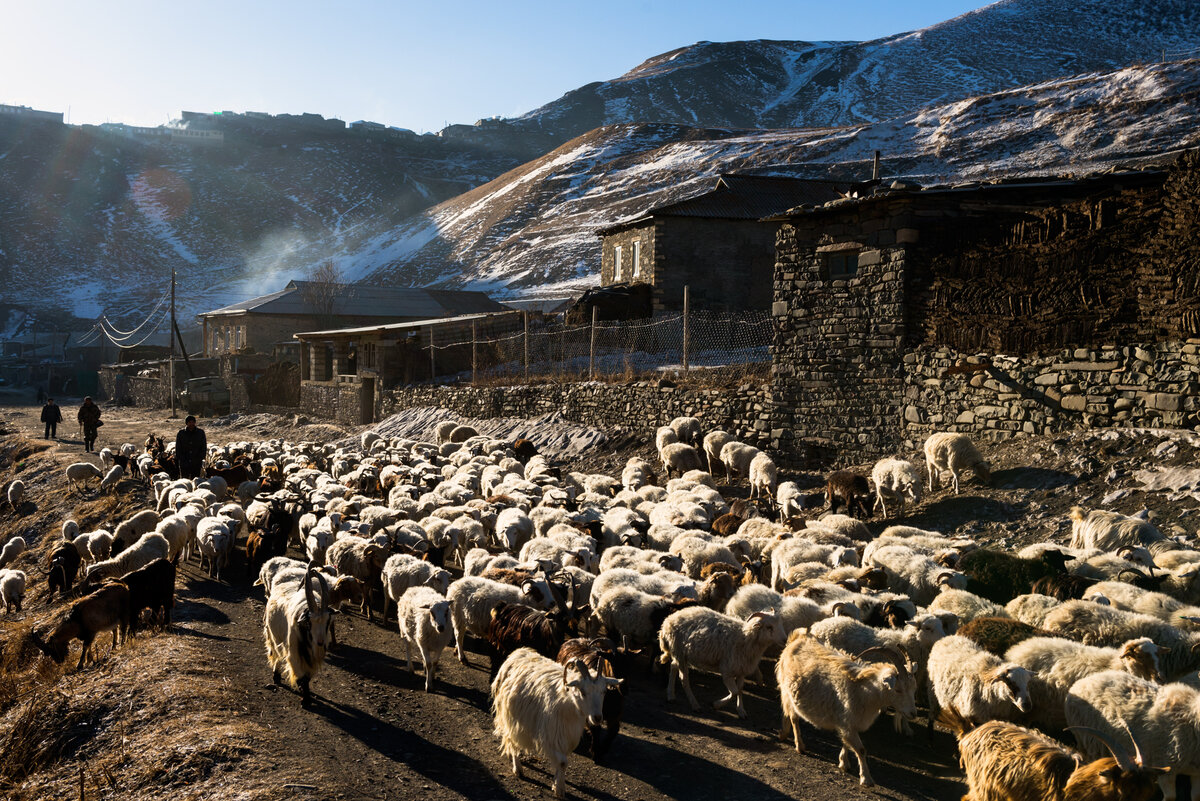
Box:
[0,388,1200,801]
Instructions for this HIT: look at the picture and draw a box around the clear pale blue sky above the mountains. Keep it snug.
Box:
[0,0,985,131]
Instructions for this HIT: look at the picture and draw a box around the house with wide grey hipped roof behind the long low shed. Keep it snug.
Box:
[200,281,506,356]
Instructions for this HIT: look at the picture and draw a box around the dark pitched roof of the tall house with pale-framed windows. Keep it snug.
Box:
[598,175,852,235]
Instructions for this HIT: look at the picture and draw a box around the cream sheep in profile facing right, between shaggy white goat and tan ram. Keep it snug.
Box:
[659,607,785,718]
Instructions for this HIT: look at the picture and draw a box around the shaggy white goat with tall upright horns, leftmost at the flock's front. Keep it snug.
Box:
[263,568,334,709]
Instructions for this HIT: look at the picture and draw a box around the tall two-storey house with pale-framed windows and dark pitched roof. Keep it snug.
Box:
[598,175,851,312]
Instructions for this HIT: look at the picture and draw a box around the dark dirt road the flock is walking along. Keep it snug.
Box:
[0,395,964,801]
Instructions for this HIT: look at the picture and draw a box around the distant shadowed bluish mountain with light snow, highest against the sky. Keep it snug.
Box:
[508,0,1200,139]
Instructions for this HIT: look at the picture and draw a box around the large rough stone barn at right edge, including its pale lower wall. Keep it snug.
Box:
[772,151,1200,463]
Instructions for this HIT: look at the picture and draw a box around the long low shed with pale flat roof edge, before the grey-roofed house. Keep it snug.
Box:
[295,311,527,426]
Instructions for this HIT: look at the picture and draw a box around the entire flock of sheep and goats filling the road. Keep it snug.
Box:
[0,417,1200,801]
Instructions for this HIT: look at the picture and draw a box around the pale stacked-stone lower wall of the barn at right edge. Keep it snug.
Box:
[900,339,1200,447]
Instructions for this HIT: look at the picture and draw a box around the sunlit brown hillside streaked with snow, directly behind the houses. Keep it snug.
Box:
[358,60,1200,295]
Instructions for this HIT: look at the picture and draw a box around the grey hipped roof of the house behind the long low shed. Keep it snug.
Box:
[202,281,504,319]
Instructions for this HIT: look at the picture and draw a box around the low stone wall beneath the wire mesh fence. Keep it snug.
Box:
[386,381,770,445]
